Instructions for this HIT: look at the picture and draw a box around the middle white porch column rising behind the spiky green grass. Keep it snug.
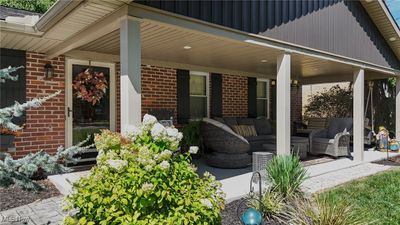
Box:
[276,52,291,155]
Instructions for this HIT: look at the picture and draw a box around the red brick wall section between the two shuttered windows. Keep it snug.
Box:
[222,74,248,117]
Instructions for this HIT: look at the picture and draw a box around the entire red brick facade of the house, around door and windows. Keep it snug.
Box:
[9,56,301,156]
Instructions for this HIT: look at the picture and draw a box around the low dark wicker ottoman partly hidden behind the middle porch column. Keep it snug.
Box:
[263,136,310,159]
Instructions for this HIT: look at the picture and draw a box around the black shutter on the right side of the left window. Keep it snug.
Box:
[210,73,222,118]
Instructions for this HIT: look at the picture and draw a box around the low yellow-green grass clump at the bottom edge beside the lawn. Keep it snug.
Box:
[285,197,368,225]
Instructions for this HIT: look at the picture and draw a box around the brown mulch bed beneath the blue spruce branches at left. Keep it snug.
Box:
[0,180,61,211]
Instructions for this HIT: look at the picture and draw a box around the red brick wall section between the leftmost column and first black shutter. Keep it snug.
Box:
[142,65,177,123]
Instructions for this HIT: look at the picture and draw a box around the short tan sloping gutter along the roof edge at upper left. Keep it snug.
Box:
[34,0,84,32]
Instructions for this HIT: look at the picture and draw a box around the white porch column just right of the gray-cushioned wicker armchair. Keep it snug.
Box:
[353,69,364,161]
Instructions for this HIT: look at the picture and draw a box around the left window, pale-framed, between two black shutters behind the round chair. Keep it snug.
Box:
[189,71,209,119]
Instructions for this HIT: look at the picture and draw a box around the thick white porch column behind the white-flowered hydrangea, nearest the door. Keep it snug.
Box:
[120,18,142,131]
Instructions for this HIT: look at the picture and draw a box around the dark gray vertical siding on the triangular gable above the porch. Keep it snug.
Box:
[139,0,400,69]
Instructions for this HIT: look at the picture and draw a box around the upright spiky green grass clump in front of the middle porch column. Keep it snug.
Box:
[266,155,307,199]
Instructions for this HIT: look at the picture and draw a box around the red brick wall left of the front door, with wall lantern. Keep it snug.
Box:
[14,52,65,157]
